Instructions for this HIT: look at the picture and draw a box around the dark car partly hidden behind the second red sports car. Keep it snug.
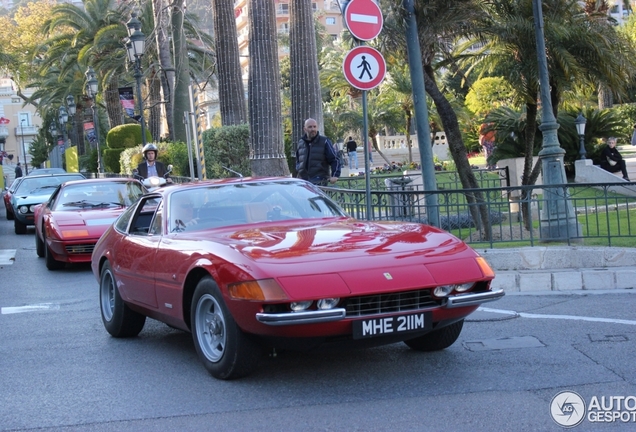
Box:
[11,173,84,234]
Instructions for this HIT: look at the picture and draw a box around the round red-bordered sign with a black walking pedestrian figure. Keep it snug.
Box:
[342,46,386,90]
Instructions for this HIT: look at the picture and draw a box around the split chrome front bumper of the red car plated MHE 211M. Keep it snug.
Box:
[256,290,505,326]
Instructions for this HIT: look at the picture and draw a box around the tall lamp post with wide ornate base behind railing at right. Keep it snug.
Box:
[532,0,580,241]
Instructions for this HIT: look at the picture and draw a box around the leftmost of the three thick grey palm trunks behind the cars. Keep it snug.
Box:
[212,0,247,126]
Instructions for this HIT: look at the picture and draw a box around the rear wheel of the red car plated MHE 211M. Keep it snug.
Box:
[99,262,146,338]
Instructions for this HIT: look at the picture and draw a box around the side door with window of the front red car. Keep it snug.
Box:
[114,195,161,308]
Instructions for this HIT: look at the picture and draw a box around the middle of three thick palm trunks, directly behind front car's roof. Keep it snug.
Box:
[248,0,289,176]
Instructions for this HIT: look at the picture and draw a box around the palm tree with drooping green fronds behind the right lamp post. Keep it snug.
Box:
[459,0,635,230]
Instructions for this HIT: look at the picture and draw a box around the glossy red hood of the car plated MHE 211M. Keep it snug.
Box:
[184,219,484,296]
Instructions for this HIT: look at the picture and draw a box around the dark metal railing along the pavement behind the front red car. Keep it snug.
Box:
[322,180,636,247]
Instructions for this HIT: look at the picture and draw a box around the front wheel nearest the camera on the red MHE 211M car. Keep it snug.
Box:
[190,276,262,380]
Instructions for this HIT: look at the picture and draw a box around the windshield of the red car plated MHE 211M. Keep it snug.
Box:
[168,180,346,232]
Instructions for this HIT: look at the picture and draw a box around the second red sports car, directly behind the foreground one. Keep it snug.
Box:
[35,178,146,270]
